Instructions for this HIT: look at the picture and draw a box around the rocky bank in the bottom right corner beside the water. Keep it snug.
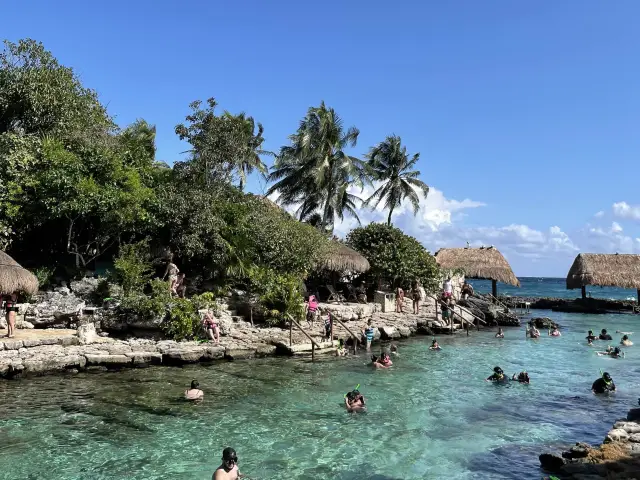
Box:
[539,408,640,480]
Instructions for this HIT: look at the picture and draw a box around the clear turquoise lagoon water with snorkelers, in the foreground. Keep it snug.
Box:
[0,311,640,480]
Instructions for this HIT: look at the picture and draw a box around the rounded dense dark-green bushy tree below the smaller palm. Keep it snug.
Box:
[346,223,439,291]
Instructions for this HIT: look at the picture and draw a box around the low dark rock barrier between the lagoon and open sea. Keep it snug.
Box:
[498,296,637,314]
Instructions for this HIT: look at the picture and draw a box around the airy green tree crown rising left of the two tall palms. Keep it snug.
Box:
[175,98,269,189]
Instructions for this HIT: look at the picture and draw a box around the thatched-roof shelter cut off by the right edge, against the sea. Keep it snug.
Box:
[567,253,640,305]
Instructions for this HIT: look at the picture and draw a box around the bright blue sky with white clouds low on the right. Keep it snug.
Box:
[5,0,640,276]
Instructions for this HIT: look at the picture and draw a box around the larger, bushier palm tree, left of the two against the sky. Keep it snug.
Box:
[267,102,367,230]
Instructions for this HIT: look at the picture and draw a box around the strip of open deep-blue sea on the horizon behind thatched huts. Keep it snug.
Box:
[469,277,638,300]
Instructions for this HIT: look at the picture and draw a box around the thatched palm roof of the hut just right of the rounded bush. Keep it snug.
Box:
[435,247,520,287]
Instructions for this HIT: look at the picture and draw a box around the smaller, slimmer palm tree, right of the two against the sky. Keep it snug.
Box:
[364,135,429,225]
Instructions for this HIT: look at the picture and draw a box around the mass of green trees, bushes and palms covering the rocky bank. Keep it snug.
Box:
[0,40,440,338]
